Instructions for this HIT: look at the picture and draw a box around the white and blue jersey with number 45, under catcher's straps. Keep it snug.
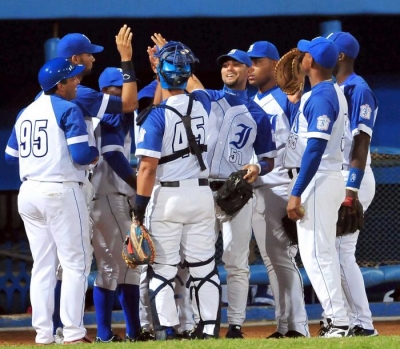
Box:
[135,90,211,181]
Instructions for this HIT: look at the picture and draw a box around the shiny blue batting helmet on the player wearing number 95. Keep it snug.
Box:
[38,58,85,92]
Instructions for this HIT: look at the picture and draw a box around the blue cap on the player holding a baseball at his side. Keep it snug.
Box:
[297,36,339,69]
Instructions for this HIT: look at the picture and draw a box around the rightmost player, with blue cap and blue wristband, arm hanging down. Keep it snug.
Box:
[328,32,378,336]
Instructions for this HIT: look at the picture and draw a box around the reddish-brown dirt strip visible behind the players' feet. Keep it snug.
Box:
[0,320,400,346]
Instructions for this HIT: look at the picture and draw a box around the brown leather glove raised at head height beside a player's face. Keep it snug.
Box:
[274,48,305,95]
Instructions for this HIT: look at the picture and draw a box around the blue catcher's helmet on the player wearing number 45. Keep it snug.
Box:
[155,41,199,90]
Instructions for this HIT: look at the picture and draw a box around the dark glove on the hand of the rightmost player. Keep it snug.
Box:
[336,197,364,236]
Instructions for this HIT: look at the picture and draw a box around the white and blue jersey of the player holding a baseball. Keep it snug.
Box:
[284,81,348,171]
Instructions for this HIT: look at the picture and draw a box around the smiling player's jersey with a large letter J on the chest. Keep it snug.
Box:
[207,87,277,179]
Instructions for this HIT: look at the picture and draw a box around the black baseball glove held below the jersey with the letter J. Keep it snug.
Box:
[216,170,253,216]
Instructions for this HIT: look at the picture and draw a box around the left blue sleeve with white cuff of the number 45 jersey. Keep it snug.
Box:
[135,108,165,159]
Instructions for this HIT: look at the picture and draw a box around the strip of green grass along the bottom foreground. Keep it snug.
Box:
[3,336,400,349]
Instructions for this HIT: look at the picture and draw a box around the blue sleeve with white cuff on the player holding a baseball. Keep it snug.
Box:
[303,94,338,141]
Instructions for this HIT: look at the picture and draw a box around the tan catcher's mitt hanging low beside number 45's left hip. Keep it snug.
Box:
[122,222,156,269]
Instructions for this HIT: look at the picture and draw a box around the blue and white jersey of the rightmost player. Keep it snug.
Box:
[340,73,378,166]
